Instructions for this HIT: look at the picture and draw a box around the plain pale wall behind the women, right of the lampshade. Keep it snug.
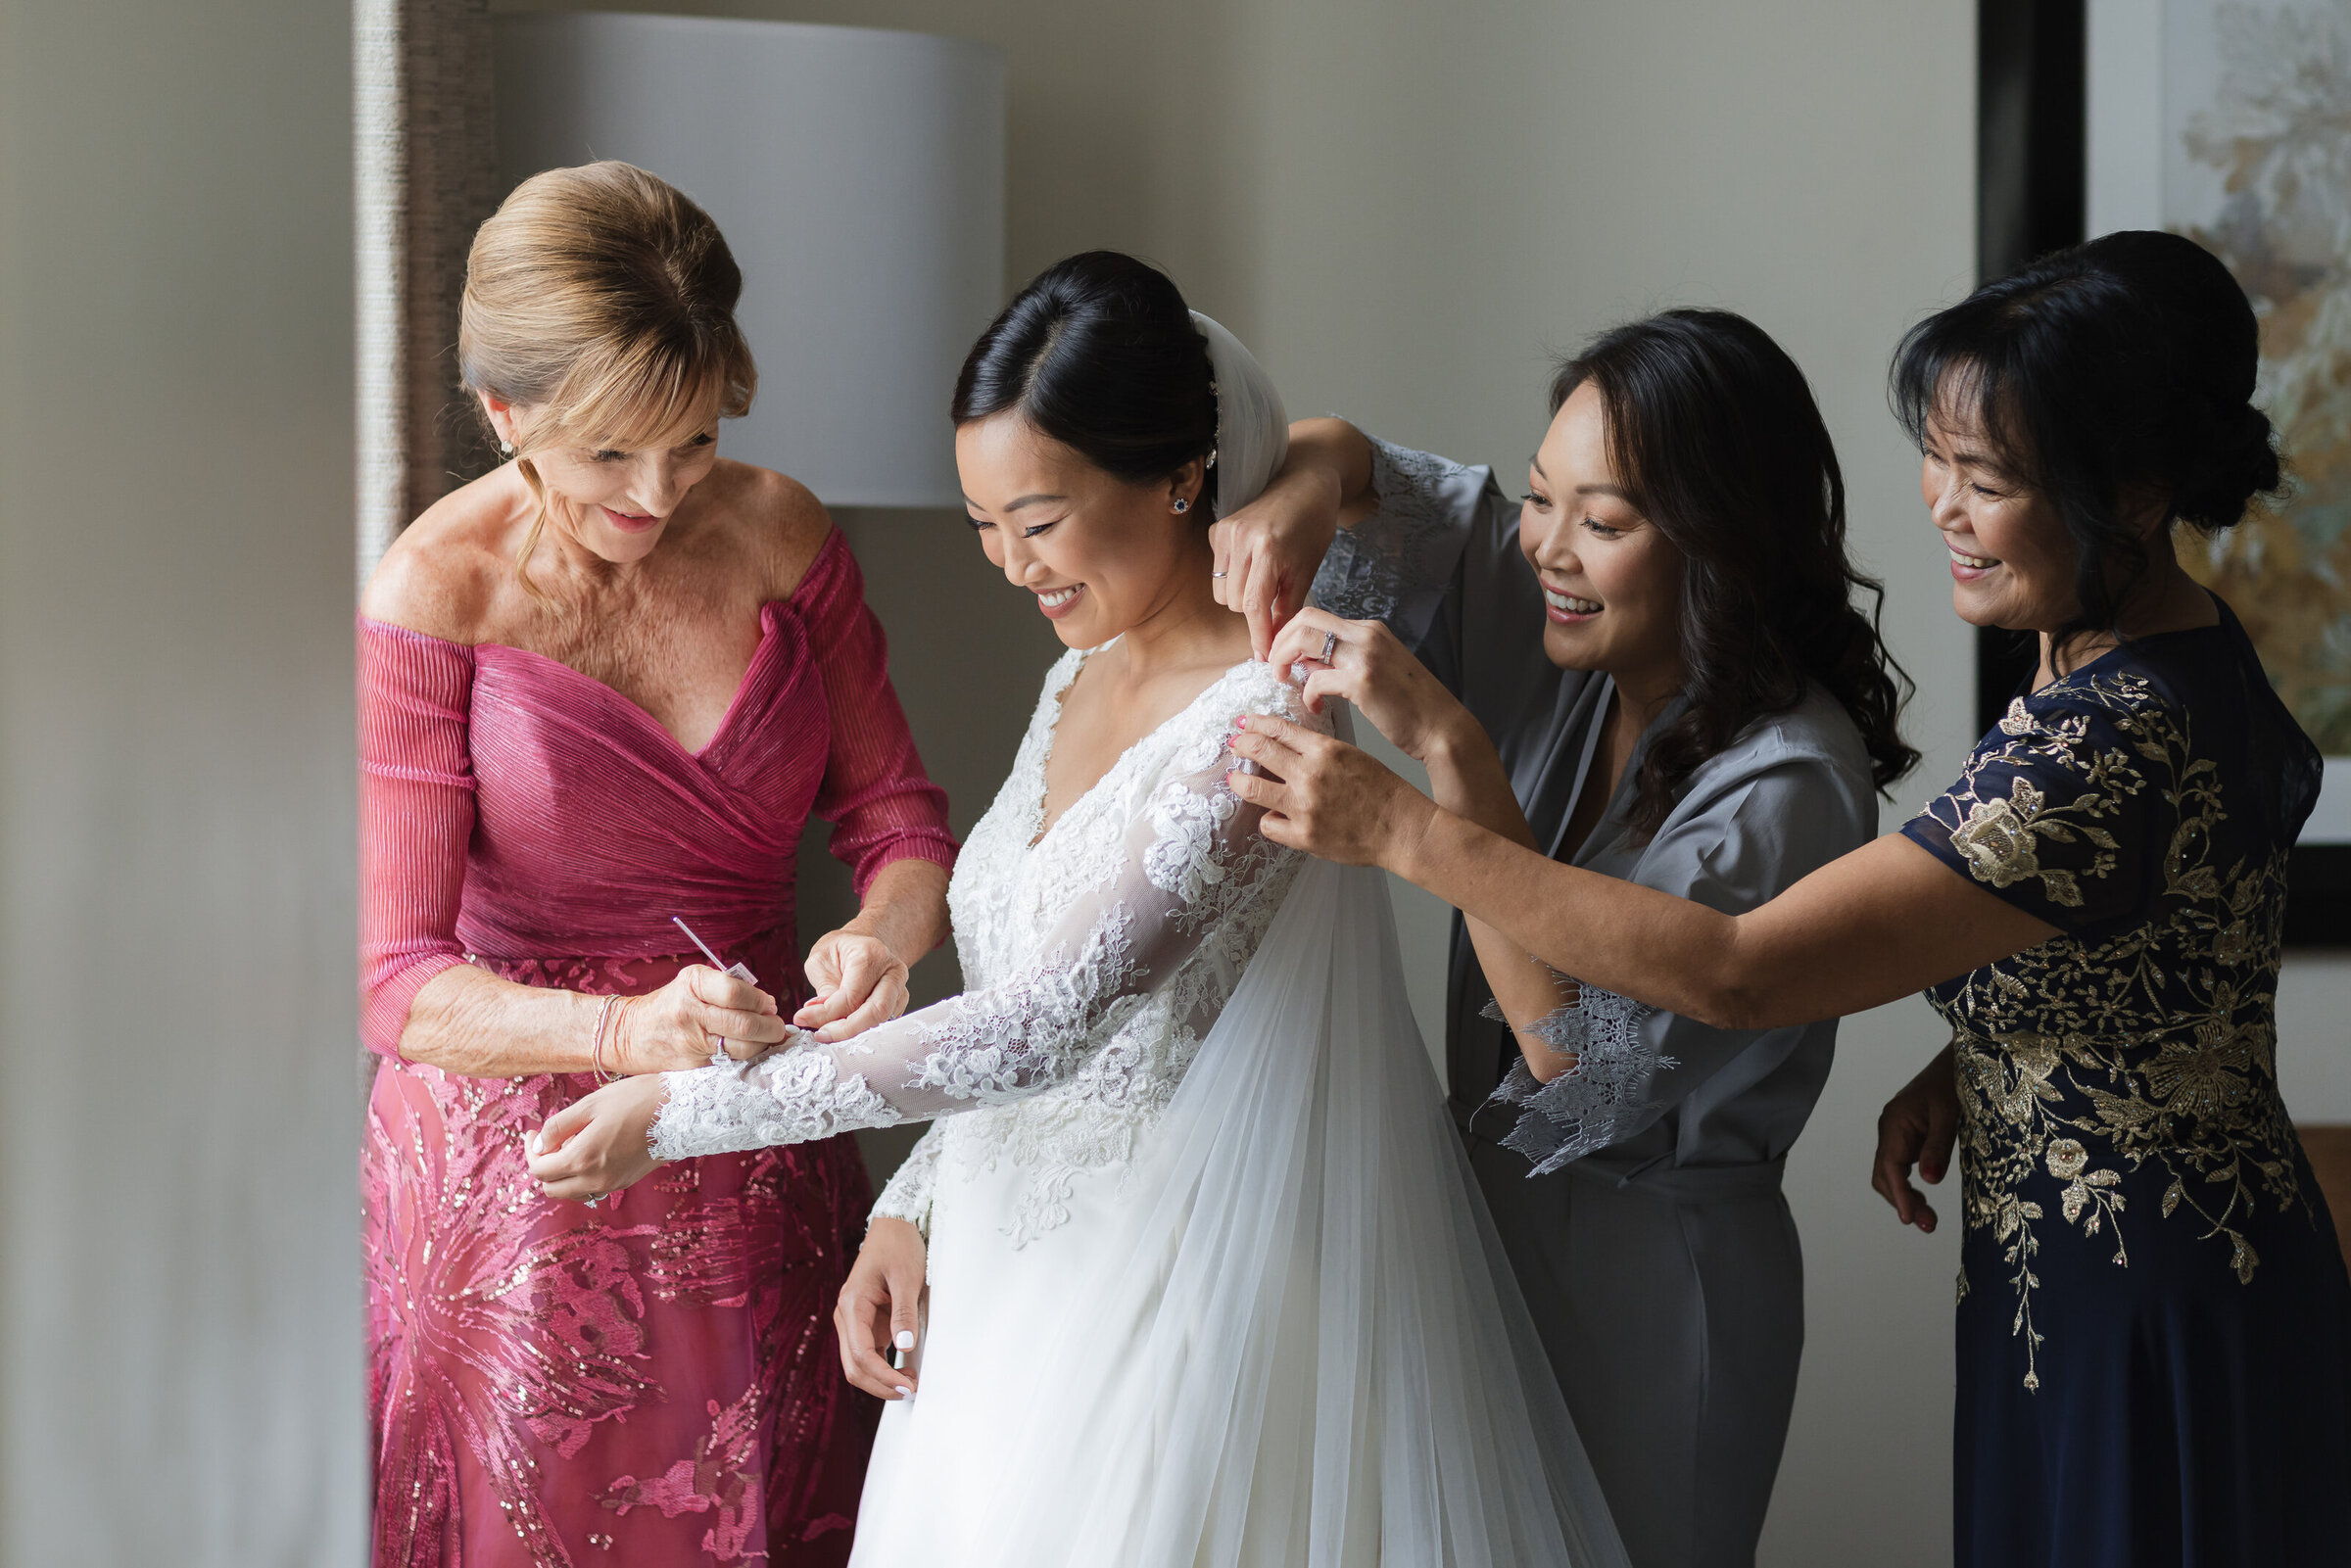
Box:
[504,0,1975,1563]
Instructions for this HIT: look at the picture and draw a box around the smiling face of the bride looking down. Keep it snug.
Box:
[954,409,1209,648]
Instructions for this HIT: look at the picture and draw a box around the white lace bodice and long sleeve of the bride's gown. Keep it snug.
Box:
[653,653,1323,1241]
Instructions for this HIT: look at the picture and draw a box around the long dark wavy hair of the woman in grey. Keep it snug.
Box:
[1552,310,1918,834]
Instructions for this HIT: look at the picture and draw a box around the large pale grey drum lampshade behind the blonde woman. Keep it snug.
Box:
[496,12,1004,505]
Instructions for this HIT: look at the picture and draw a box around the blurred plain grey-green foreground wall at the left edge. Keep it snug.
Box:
[0,0,366,1568]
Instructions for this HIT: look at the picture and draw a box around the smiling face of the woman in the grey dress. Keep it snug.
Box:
[1518,381,1681,698]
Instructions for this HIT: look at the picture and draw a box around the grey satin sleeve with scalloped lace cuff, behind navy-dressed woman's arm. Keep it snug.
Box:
[1488,757,1867,1175]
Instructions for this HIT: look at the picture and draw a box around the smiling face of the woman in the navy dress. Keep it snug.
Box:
[1918,395,2079,633]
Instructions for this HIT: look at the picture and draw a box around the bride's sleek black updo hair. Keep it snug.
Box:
[952,252,1216,512]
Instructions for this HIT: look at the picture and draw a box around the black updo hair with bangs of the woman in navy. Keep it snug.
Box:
[1891,230,2280,644]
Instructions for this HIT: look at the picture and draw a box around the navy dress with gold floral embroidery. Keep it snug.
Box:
[1902,606,2351,1568]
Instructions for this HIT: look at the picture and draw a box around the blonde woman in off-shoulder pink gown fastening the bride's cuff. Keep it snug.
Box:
[360,165,954,1568]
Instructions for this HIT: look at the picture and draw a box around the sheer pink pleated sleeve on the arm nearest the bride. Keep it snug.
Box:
[801,536,954,898]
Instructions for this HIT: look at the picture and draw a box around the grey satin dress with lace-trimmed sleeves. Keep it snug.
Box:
[1315,442,1876,1568]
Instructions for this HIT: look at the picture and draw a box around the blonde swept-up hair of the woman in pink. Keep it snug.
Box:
[456,160,759,593]
